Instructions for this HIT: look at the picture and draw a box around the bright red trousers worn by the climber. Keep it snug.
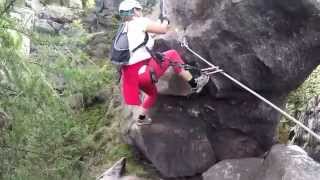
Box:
[121,50,184,109]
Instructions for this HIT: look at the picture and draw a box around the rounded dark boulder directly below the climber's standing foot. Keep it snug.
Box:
[126,102,216,177]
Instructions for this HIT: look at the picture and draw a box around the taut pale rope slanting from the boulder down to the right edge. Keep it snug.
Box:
[180,37,320,141]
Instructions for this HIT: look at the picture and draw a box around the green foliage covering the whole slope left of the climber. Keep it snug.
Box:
[0,9,152,180]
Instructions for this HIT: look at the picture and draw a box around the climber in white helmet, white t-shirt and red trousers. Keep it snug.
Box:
[119,0,209,125]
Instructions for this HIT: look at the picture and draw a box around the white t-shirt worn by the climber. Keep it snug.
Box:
[127,17,154,65]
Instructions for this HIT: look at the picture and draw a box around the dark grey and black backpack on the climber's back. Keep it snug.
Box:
[111,23,149,65]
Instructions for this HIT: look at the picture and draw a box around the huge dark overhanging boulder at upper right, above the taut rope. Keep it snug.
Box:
[170,0,320,93]
